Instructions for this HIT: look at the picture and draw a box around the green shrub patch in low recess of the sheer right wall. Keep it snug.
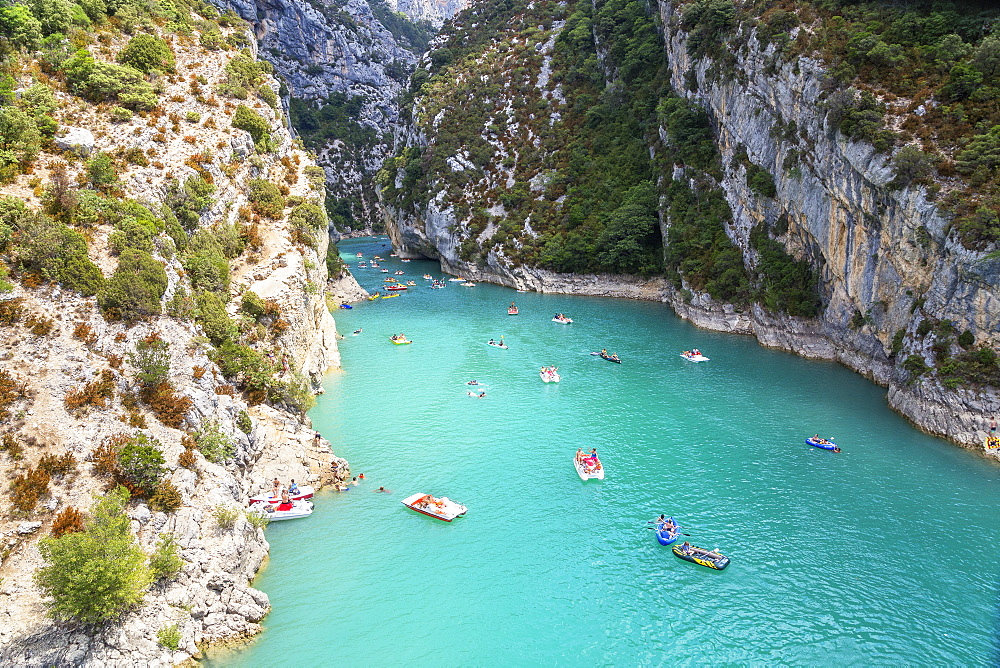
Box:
[750,226,820,318]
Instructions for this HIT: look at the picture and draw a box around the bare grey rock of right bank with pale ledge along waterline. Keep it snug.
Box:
[384,0,1000,456]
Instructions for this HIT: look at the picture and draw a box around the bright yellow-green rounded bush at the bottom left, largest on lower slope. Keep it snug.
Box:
[35,487,152,625]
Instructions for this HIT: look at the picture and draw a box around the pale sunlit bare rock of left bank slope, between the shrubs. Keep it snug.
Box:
[0,15,358,666]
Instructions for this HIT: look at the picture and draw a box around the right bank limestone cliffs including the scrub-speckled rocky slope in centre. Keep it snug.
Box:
[381,0,1000,456]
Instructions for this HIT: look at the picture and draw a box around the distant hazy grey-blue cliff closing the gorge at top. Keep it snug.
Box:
[216,0,465,235]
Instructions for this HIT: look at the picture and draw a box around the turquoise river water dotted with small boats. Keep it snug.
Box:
[223,239,1000,667]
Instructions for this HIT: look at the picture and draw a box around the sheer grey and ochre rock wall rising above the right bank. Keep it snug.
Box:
[659,2,1000,449]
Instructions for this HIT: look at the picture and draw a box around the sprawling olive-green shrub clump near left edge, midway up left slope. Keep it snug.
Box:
[12,214,104,297]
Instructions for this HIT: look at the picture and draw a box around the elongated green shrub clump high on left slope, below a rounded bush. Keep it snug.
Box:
[63,49,158,110]
